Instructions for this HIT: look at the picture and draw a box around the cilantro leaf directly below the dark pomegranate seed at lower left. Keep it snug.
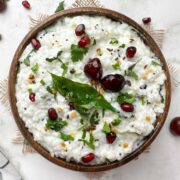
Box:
[46,119,68,131]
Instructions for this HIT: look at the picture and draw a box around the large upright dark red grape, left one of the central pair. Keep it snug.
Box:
[84,58,102,80]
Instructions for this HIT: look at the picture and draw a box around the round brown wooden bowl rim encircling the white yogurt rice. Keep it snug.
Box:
[9,7,171,172]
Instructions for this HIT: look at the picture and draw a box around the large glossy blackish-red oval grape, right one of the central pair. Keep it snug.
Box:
[101,74,126,92]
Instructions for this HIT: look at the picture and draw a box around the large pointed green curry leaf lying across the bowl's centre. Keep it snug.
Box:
[51,74,117,114]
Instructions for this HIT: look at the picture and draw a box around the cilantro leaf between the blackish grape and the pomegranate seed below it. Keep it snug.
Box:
[117,92,135,104]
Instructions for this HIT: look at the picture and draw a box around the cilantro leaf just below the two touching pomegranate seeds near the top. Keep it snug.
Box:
[71,44,89,62]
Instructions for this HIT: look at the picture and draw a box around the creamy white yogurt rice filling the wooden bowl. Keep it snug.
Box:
[16,16,166,164]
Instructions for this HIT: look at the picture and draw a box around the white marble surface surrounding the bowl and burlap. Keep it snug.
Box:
[0,0,180,180]
